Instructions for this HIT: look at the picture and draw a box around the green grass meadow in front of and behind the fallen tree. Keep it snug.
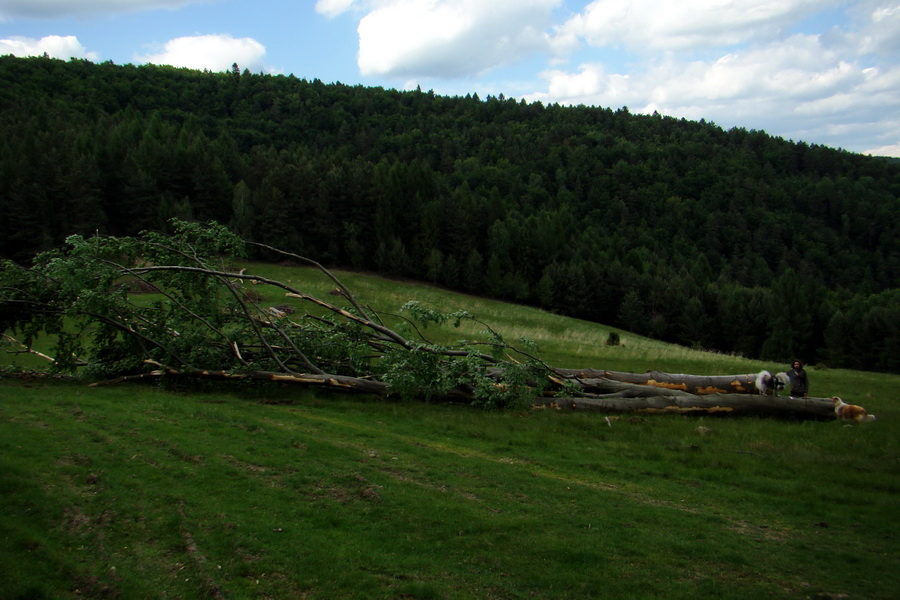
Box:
[0,266,900,599]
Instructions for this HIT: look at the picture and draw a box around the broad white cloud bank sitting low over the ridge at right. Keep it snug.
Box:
[529,30,900,150]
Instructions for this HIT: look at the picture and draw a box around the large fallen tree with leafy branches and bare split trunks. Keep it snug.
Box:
[0,221,833,418]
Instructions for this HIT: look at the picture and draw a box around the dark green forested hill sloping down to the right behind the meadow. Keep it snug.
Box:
[0,56,900,371]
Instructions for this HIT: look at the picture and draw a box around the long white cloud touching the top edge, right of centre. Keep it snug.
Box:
[556,0,837,52]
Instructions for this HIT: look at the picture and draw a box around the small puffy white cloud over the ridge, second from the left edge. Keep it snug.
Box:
[135,35,269,72]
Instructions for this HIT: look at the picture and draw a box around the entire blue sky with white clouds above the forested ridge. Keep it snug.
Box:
[0,0,900,156]
